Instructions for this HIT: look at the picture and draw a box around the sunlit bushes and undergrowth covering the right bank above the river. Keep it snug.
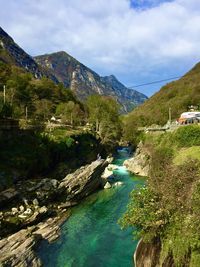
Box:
[121,130,200,267]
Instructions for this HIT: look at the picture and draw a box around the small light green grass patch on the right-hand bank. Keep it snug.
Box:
[173,146,200,165]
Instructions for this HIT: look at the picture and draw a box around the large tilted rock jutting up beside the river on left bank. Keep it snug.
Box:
[59,160,108,202]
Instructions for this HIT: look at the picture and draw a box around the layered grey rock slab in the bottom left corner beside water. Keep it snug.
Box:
[0,216,69,267]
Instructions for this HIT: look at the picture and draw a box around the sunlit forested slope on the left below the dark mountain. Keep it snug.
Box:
[0,62,85,122]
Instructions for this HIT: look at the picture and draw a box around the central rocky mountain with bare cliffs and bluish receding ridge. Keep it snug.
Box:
[35,51,147,112]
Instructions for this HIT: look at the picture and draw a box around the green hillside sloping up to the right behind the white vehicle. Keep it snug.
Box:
[128,63,200,125]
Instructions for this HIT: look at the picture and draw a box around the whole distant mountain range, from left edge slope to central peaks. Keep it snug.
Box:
[0,27,147,112]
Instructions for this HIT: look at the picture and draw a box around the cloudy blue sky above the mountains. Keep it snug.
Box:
[0,0,200,96]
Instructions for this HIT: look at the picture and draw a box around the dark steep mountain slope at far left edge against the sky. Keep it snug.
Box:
[0,27,58,82]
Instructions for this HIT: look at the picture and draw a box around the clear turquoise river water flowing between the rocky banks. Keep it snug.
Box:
[38,149,143,267]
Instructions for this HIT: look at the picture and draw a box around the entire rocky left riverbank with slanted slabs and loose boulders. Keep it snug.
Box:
[0,160,109,267]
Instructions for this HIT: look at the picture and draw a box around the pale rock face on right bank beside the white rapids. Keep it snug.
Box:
[124,143,150,176]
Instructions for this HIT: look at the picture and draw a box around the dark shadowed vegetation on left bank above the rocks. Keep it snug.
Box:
[0,130,104,190]
